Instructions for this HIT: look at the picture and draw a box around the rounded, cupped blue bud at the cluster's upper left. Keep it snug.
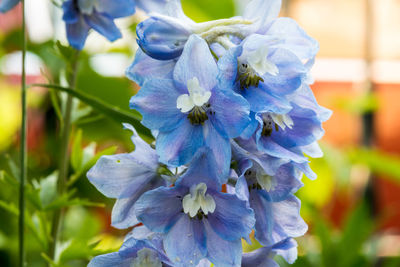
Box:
[136,15,192,60]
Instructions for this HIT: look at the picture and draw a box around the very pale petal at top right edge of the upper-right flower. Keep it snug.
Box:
[266,18,319,60]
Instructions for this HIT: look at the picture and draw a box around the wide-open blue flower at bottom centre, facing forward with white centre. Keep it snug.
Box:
[135,148,254,266]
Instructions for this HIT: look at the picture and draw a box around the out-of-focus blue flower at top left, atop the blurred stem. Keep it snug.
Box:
[62,0,135,50]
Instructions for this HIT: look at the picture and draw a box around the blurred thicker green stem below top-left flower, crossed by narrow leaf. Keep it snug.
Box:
[49,51,79,261]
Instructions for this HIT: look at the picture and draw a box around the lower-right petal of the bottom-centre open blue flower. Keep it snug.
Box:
[204,221,242,267]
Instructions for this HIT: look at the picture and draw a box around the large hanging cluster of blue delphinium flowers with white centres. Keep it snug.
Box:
[87,0,331,267]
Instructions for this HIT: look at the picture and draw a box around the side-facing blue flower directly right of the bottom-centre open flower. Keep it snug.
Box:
[232,140,307,246]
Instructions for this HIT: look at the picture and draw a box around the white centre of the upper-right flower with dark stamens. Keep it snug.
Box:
[247,45,279,76]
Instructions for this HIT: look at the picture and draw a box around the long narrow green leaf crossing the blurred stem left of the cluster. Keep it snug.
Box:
[30,84,152,137]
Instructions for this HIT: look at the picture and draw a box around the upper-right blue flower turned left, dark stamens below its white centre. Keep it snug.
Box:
[218,34,308,113]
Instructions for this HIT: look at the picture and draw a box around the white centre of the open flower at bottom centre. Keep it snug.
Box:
[182,183,215,218]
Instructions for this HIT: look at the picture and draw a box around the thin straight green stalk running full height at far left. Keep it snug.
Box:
[18,0,28,267]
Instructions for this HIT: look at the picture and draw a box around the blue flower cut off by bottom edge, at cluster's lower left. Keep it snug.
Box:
[88,228,172,267]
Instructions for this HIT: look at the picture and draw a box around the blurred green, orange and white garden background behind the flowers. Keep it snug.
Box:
[0,0,400,267]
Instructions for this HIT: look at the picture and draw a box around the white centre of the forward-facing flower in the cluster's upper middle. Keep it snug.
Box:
[176,77,211,113]
